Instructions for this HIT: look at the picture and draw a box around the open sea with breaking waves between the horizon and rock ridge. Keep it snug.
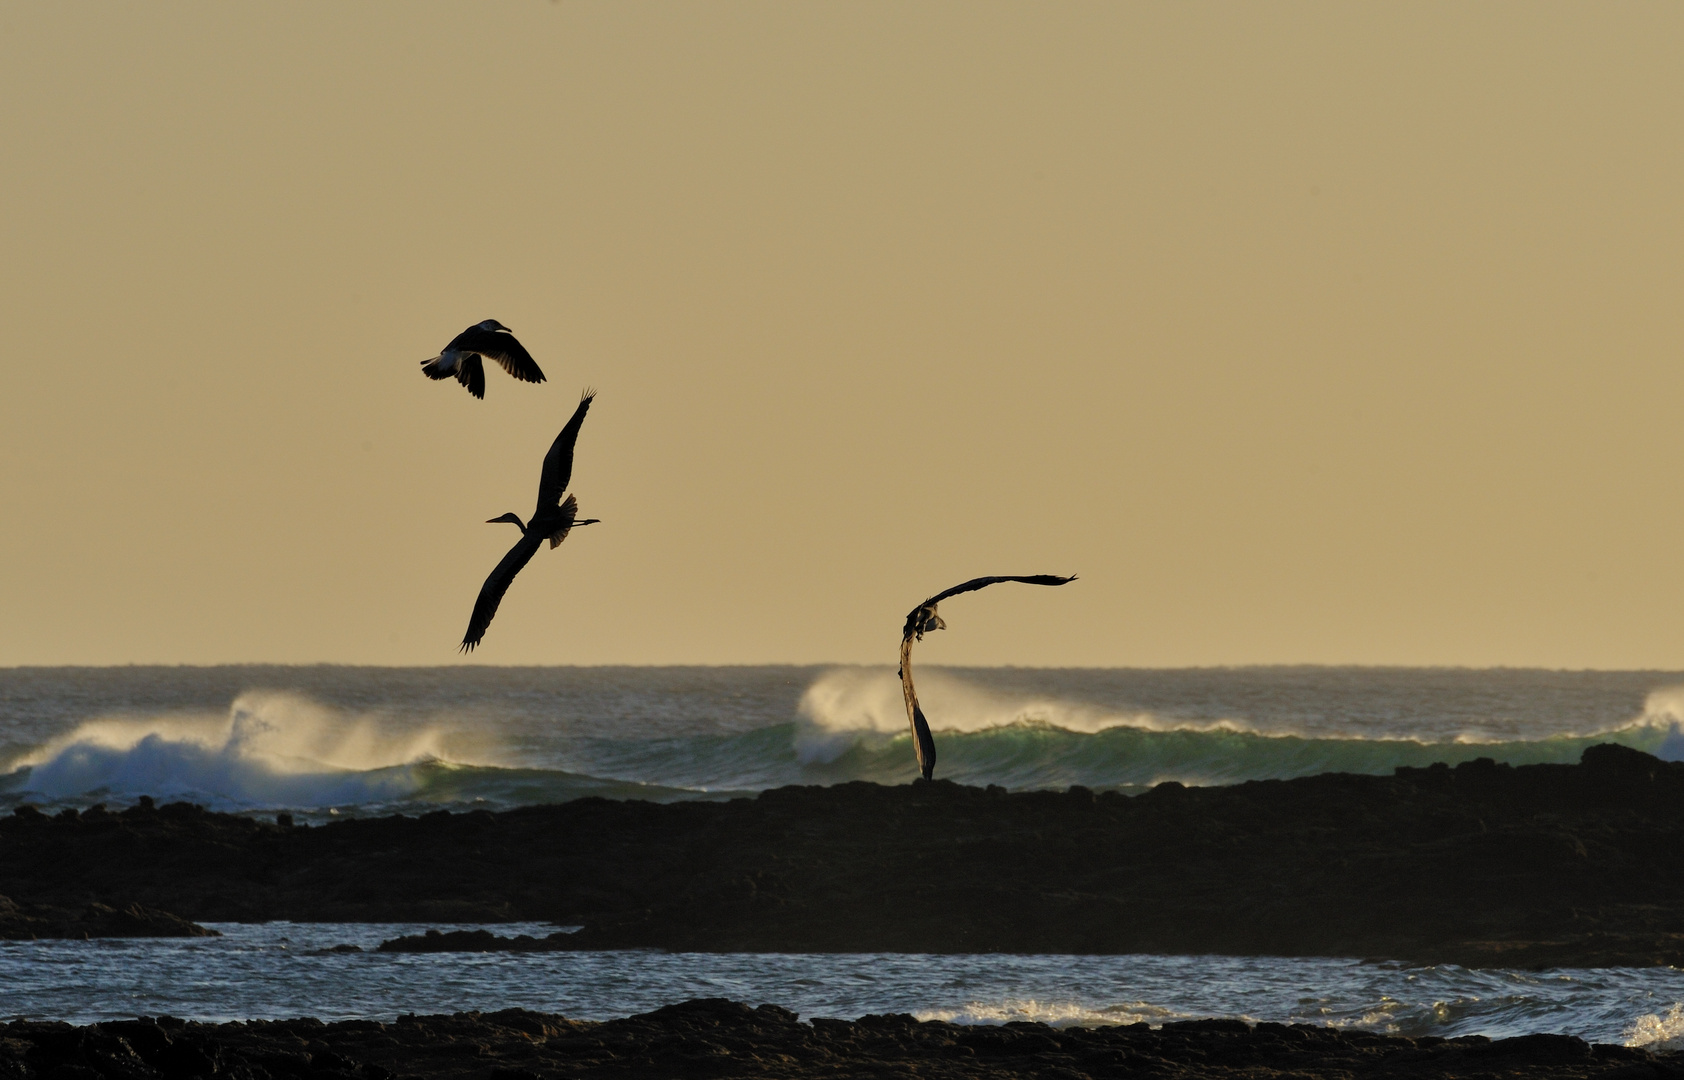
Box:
[0,667,1684,817]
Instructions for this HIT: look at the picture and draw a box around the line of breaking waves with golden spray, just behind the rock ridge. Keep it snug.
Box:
[0,669,1684,814]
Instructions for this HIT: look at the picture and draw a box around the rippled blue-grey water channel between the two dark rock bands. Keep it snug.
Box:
[0,922,1684,1045]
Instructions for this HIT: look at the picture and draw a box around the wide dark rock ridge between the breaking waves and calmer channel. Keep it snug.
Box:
[0,746,1684,967]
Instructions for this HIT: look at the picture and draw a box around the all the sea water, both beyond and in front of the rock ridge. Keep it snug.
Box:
[0,666,1684,1046]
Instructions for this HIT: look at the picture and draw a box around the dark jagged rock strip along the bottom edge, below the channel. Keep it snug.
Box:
[0,999,1684,1080]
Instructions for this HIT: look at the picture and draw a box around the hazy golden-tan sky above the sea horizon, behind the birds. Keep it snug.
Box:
[0,0,1684,667]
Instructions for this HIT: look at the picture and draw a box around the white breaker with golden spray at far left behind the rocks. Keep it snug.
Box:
[8,691,480,807]
